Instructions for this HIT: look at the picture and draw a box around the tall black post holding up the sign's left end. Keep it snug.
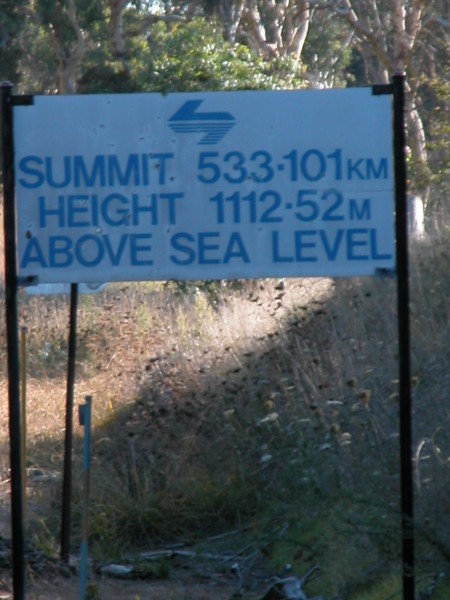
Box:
[0,82,25,600]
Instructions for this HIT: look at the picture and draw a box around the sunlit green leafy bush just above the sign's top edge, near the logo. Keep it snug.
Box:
[79,16,304,93]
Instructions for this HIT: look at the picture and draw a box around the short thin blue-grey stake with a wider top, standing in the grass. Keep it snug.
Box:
[80,396,92,600]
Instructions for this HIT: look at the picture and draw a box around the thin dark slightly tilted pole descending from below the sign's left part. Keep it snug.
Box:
[61,283,78,562]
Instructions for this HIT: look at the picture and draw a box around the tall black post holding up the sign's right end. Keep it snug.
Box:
[393,74,415,600]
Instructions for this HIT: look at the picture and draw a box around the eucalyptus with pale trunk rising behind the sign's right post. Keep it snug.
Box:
[328,0,450,202]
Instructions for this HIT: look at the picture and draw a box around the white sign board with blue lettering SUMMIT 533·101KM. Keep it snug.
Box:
[14,88,394,283]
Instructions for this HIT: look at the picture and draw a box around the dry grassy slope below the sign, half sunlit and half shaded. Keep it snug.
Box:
[0,219,450,600]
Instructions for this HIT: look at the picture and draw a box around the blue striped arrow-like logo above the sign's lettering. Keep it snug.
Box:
[169,100,236,146]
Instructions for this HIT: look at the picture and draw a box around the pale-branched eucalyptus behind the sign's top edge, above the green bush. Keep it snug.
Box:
[163,0,351,88]
